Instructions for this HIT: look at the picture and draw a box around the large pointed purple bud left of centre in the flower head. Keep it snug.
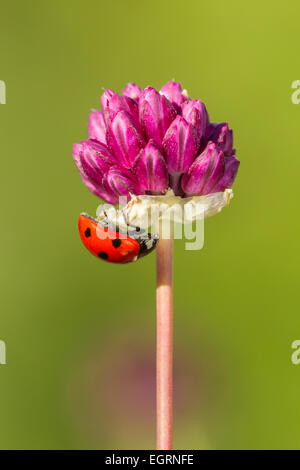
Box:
[107,111,144,168]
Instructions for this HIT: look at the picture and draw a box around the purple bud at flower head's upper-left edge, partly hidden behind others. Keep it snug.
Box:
[101,90,138,125]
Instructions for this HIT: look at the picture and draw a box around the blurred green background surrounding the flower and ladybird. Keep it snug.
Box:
[0,0,300,449]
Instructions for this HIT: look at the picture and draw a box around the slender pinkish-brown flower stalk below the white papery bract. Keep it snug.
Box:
[156,238,173,450]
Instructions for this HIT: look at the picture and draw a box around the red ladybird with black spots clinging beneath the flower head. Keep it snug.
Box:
[78,214,158,264]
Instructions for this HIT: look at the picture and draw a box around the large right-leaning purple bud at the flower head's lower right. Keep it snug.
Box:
[181,142,225,195]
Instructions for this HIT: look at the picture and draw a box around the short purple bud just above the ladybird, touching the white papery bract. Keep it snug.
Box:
[104,167,143,199]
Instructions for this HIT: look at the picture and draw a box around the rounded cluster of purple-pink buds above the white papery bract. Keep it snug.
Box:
[73,81,239,204]
